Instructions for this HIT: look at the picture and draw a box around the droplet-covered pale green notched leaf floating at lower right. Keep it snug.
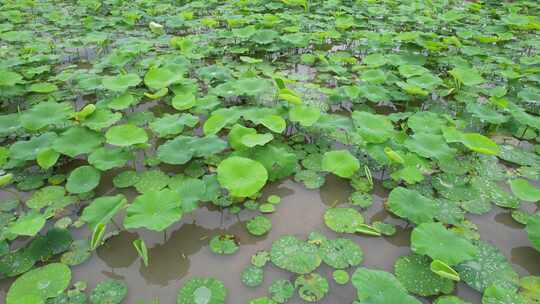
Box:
[455,241,519,292]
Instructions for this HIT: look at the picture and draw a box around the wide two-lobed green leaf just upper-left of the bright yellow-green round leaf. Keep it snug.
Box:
[157,135,227,165]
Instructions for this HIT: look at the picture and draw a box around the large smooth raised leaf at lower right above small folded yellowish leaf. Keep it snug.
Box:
[411,223,478,266]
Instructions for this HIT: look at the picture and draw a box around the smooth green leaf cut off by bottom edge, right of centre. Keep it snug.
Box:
[351,268,421,304]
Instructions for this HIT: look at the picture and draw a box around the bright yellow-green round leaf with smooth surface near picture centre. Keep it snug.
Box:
[217,156,268,197]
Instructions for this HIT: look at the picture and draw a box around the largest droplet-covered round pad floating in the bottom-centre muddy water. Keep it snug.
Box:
[270,235,321,274]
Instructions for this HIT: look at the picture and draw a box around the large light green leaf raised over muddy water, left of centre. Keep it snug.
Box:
[124,189,183,231]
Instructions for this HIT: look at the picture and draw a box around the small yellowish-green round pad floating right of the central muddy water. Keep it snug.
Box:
[324,208,364,233]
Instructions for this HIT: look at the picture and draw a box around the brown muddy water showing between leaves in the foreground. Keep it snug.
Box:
[0,177,540,304]
